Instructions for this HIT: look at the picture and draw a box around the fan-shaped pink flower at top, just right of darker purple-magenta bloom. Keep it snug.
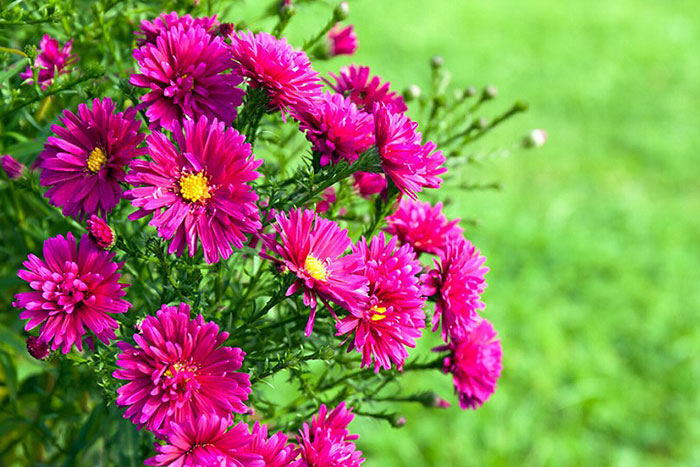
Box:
[230,31,322,112]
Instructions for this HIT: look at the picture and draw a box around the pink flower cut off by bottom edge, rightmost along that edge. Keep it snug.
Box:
[297,402,365,467]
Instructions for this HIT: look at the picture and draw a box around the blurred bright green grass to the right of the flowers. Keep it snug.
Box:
[318,0,700,467]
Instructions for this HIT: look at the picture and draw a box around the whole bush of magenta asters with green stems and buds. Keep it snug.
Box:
[0,1,544,467]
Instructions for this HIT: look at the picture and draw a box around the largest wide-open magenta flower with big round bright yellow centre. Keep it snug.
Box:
[127,117,262,263]
